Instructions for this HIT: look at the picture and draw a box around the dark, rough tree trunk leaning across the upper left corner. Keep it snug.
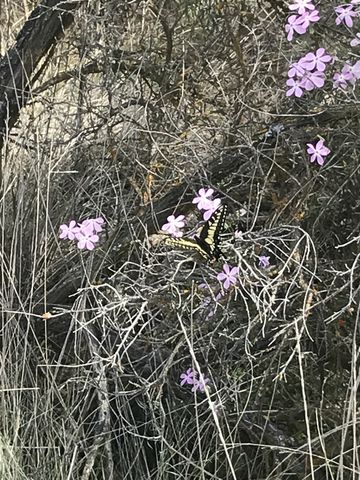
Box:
[0,0,83,149]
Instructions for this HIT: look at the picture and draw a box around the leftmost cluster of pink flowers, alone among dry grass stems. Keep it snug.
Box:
[59,217,104,250]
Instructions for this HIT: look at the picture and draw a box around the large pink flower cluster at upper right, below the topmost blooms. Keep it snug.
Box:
[286,48,333,97]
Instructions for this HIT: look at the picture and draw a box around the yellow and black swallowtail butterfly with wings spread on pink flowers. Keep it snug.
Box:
[165,204,227,260]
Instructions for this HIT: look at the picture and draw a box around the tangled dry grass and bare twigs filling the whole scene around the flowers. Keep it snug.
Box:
[0,0,360,480]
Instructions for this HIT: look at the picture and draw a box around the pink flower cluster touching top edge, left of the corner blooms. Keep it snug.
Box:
[285,0,320,42]
